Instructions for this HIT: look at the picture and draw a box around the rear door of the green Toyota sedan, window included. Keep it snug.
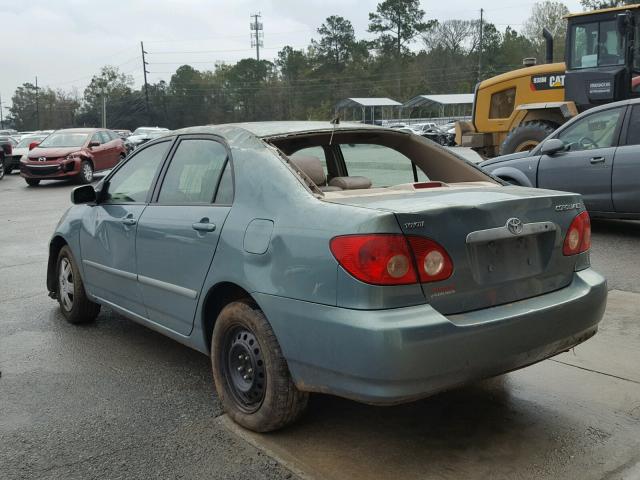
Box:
[136,136,233,335]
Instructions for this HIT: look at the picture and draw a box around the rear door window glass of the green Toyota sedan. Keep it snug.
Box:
[158,139,227,204]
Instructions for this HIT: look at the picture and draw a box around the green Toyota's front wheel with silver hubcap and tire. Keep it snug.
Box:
[56,246,100,324]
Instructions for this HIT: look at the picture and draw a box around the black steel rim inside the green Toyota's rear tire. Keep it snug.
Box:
[222,326,267,413]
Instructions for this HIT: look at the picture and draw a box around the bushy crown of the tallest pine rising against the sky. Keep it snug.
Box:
[368,0,432,58]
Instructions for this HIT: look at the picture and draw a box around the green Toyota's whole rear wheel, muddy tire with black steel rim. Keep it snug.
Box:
[211,301,309,432]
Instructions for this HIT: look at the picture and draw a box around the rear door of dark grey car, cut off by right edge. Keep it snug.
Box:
[611,104,640,213]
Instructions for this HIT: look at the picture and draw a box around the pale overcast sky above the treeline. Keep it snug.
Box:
[0,0,581,109]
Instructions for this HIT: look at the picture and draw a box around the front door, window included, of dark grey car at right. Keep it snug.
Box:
[538,106,626,212]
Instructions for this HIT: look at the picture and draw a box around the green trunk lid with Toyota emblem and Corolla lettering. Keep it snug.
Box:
[327,187,583,314]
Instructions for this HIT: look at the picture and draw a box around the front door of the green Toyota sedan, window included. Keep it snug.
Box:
[80,141,171,317]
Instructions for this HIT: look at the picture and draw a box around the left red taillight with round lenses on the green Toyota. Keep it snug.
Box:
[330,234,453,285]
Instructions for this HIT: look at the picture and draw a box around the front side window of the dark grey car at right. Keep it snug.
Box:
[558,108,623,152]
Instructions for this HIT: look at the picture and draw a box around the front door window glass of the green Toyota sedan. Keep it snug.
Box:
[106,142,171,203]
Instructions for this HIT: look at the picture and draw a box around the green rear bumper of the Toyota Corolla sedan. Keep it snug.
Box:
[255,269,607,404]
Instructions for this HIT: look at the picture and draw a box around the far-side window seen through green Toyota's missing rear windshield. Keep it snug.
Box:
[340,143,428,187]
